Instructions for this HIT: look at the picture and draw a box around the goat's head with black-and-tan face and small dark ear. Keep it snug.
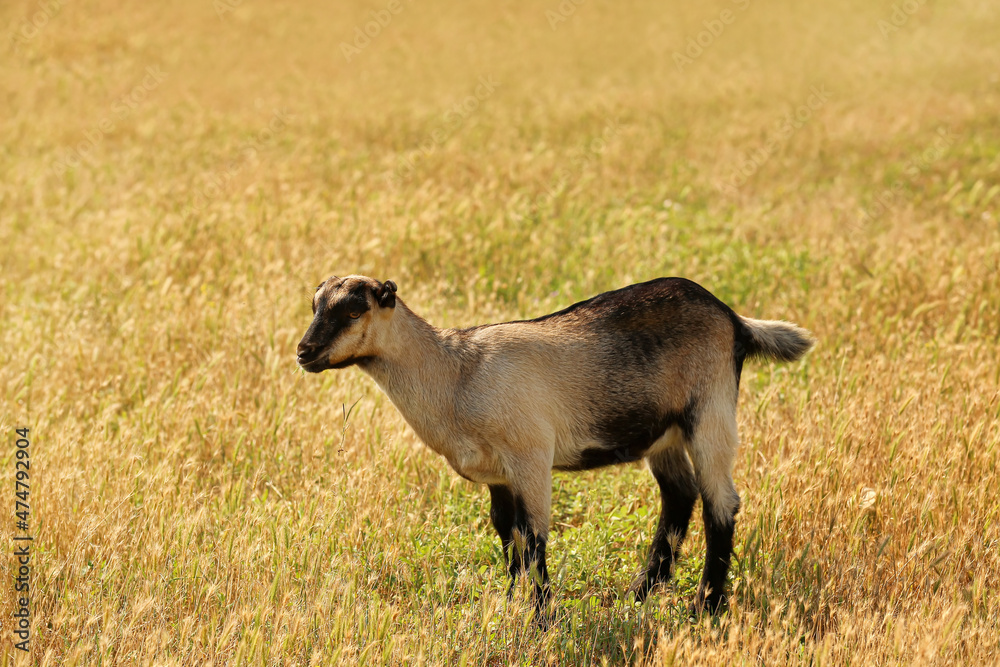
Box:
[298,276,396,373]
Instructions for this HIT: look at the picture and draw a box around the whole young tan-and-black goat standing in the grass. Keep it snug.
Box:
[298,276,813,618]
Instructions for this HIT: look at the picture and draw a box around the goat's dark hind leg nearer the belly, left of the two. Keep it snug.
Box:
[629,450,698,602]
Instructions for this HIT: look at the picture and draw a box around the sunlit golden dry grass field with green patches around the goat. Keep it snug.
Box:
[0,0,1000,667]
